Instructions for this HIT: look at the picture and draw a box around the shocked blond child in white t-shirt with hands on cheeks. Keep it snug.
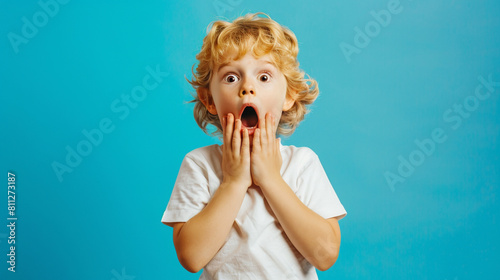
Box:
[162,13,346,279]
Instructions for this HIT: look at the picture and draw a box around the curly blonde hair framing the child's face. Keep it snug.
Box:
[189,13,319,136]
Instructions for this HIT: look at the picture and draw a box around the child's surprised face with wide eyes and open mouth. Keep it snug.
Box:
[207,53,294,135]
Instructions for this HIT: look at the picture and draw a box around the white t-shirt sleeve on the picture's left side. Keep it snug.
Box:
[161,154,210,226]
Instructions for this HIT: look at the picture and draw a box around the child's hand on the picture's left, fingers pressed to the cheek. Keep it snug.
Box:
[222,113,252,189]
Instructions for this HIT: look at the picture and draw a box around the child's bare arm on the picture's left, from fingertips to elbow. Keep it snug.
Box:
[173,114,252,272]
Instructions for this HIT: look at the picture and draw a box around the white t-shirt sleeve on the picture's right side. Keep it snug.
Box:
[297,148,347,220]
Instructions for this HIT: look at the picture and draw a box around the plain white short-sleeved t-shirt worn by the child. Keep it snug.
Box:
[162,145,346,280]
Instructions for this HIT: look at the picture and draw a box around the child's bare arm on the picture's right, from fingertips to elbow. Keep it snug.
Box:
[251,115,340,270]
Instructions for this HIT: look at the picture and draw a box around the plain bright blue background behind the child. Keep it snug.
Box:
[0,0,500,280]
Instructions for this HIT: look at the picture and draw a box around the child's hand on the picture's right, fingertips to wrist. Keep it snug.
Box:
[250,113,282,188]
